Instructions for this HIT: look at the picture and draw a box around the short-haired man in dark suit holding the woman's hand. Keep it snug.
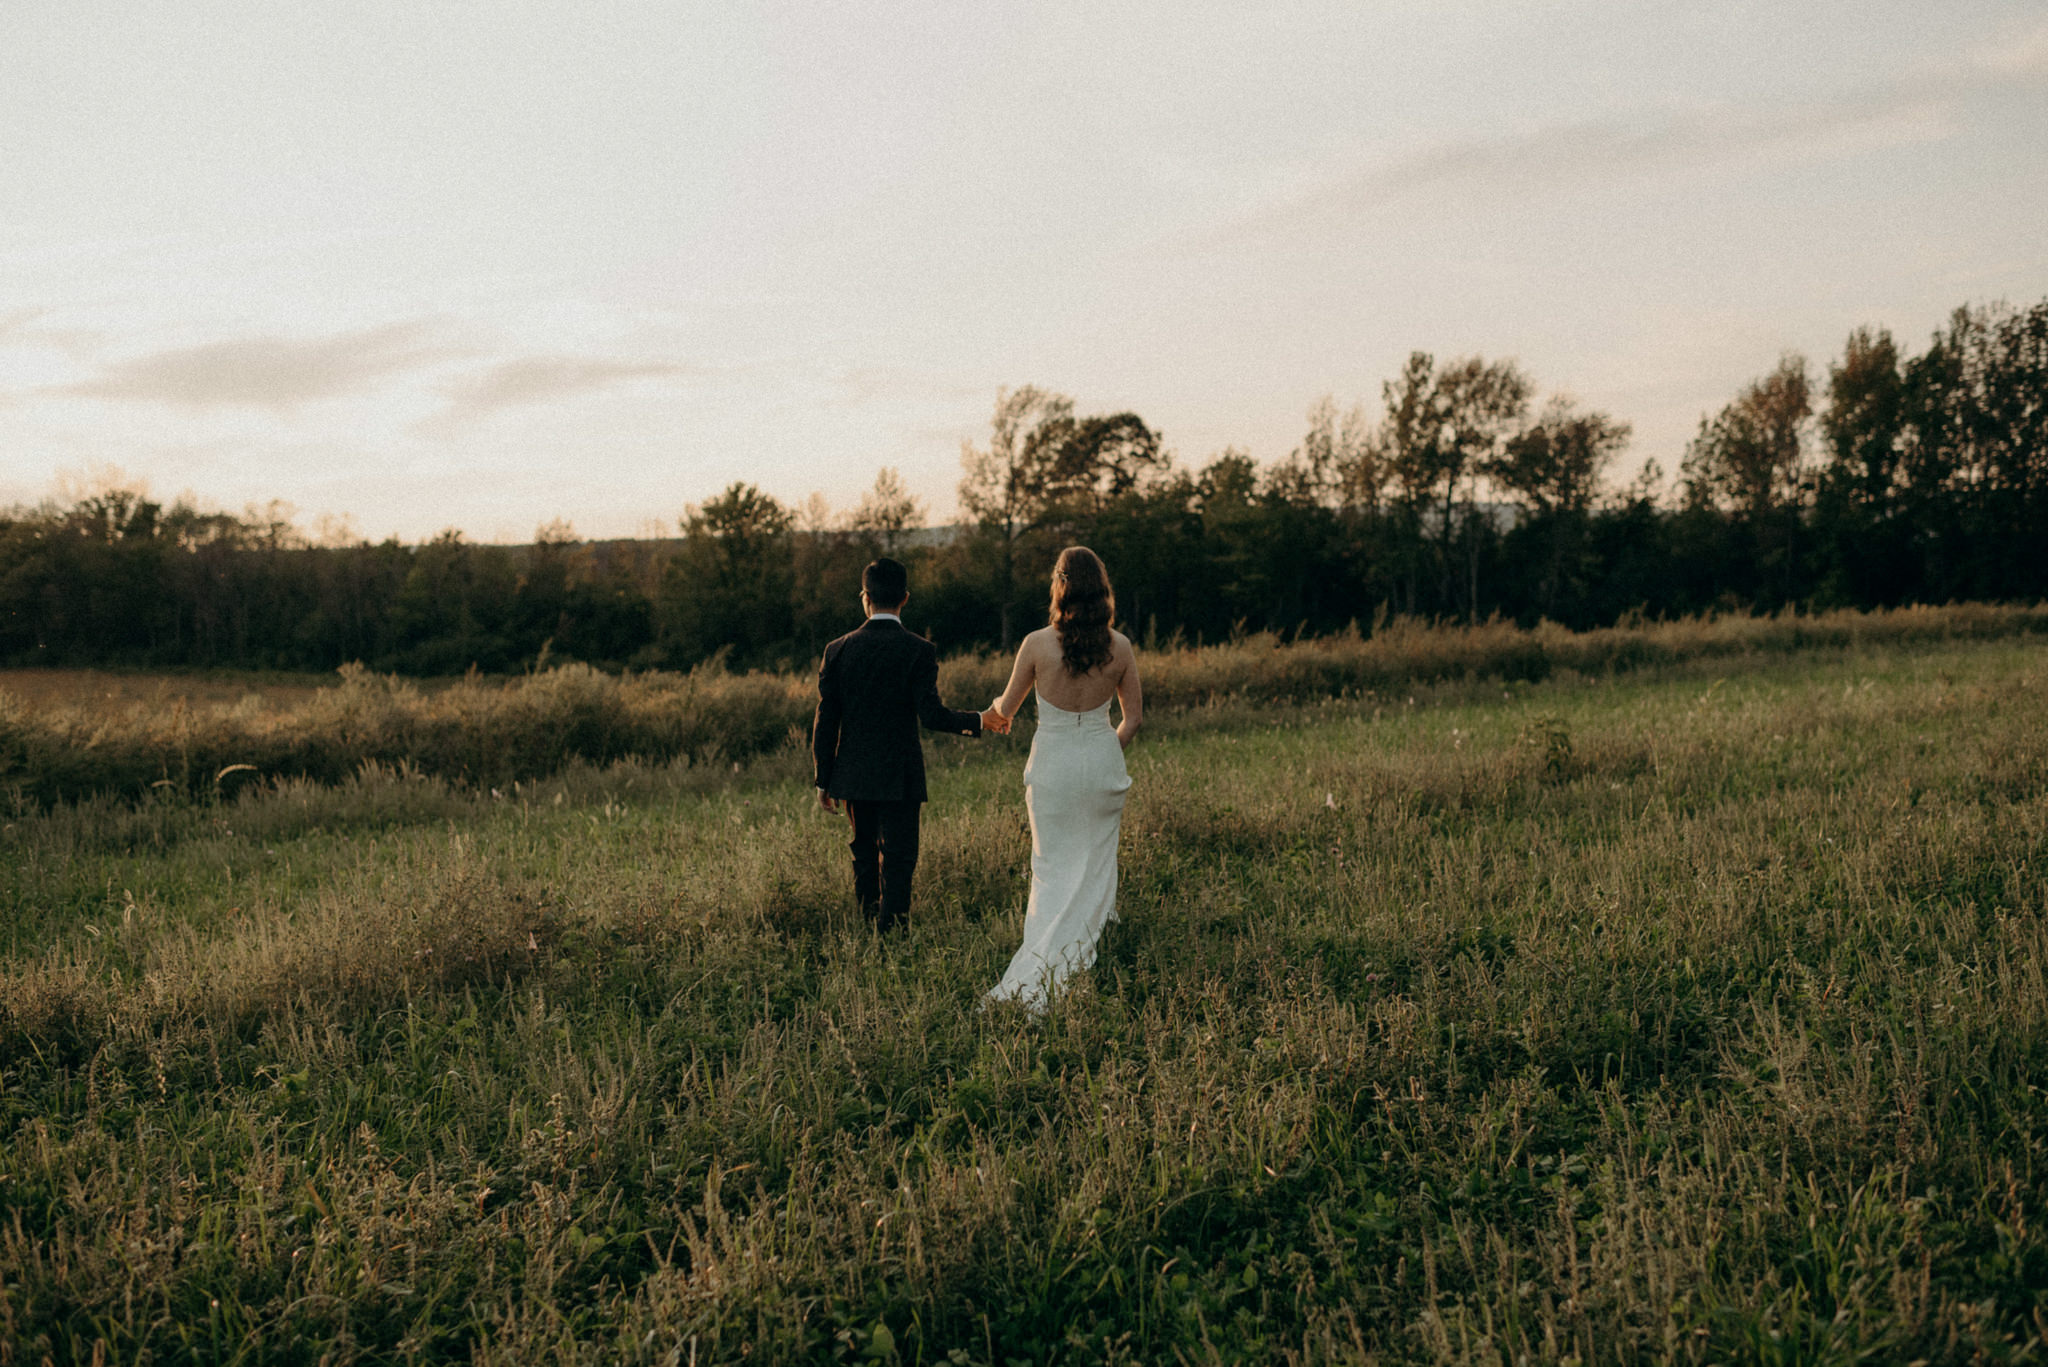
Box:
[811,557,1010,930]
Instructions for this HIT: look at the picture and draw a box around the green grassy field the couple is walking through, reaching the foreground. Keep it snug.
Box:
[0,637,2048,1365]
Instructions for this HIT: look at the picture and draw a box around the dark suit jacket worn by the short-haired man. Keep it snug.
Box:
[811,617,981,801]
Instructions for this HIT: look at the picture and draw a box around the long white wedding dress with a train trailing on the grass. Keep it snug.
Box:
[989,697,1130,1010]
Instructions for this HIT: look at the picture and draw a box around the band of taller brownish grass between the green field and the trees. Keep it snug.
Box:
[0,605,2048,803]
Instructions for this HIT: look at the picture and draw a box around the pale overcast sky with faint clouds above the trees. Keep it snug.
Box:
[0,0,2048,541]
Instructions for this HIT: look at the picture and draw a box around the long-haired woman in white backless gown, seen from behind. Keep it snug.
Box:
[989,545,1145,1010]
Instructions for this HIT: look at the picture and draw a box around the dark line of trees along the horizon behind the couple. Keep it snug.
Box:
[0,301,2048,674]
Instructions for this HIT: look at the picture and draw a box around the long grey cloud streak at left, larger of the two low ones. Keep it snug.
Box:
[57,320,457,410]
